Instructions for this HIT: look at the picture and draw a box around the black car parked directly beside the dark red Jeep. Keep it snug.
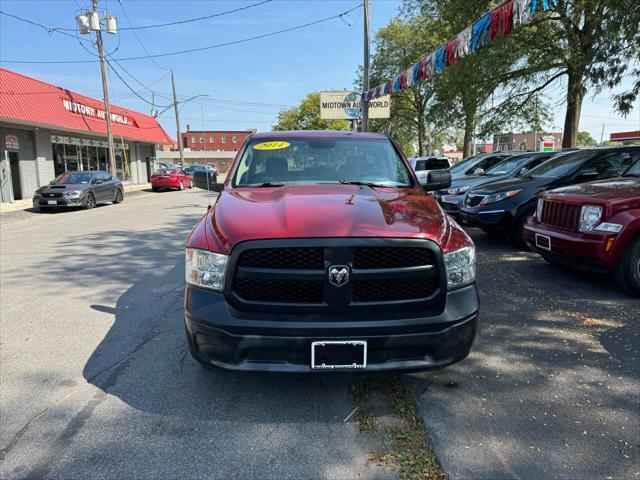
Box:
[460,146,640,247]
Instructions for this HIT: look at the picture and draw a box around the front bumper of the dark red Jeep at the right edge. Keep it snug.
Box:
[524,221,616,273]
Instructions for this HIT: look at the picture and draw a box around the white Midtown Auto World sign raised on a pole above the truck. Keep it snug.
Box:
[320,91,391,120]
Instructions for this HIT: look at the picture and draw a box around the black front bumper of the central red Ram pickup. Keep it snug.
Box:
[185,285,480,372]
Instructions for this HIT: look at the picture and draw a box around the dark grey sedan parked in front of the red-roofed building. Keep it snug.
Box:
[33,171,124,210]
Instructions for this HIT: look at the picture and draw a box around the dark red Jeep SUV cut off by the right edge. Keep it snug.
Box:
[525,161,640,296]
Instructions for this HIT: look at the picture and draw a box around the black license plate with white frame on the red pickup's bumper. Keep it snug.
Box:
[311,340,367,370]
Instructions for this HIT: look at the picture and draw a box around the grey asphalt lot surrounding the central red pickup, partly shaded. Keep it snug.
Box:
[0,190,640,479]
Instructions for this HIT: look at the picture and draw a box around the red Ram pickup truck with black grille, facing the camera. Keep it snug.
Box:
[185,131,479,372]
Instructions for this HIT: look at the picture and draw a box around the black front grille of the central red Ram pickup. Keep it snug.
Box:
[226,239,444,311]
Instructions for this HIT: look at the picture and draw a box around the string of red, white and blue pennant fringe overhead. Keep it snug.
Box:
[362,0,558,101]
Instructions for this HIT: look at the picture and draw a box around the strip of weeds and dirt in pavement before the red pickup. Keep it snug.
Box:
[351,375,447,480]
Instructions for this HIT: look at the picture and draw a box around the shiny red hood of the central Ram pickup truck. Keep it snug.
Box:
[212,184,451,251]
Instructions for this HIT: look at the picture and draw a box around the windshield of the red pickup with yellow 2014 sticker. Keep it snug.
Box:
[232,137,412,187]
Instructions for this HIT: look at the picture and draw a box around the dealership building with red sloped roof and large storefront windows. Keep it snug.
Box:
[0,68,173,202]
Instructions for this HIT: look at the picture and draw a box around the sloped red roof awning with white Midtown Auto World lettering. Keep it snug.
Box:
[0,68,173,144]
